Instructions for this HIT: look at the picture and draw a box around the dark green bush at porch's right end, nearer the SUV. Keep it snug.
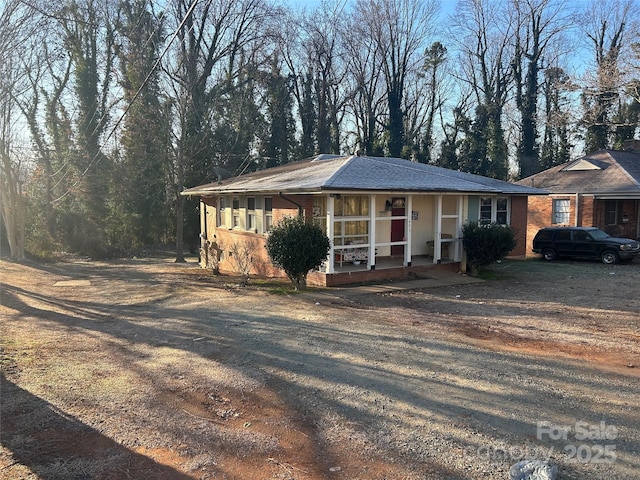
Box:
[462,222,516,275]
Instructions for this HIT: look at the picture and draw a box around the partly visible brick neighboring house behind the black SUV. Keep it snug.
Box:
[517,146,640,255]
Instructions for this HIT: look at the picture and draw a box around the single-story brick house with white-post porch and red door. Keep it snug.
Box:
[182,155,546,286]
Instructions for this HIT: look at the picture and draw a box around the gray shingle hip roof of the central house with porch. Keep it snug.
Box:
[182,155,546,195]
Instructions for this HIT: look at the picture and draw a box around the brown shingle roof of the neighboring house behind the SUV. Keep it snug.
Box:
[517,150,640,194]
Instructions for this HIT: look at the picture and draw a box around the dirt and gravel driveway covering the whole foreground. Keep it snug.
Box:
[0,258,640,480]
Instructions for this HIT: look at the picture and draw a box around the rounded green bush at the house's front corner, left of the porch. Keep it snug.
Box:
[267,216,331,290]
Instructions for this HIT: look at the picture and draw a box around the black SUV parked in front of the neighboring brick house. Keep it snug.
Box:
[533,227,640,264]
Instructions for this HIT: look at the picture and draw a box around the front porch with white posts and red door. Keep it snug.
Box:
[313,192,468,275]
